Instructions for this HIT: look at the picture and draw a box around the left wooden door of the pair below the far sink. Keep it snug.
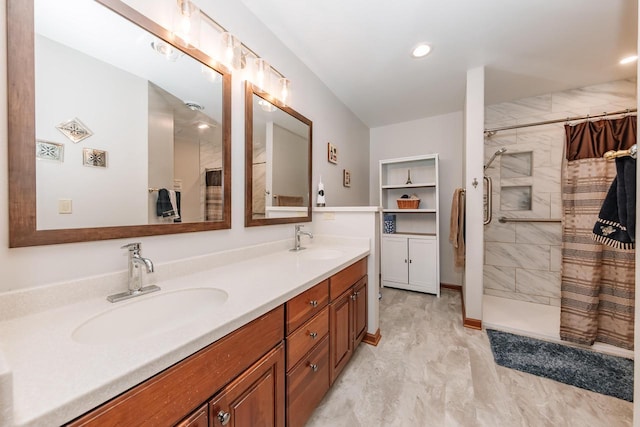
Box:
[329,289,353,384]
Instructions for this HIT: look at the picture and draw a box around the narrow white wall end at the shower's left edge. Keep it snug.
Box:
[463,67,484,320]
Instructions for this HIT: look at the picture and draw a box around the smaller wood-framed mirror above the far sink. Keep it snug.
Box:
[244,82,312,227]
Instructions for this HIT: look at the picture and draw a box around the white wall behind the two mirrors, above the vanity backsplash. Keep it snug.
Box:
[0,0,369,292]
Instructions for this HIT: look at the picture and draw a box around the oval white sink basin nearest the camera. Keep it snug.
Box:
[71,288,229,344]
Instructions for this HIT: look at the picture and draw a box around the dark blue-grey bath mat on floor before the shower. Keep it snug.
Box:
[487,329,633,402]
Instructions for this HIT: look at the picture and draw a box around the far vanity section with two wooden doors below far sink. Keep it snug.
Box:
[329,259,367,384]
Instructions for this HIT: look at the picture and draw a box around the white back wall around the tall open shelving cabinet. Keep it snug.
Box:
[368,112,463,285]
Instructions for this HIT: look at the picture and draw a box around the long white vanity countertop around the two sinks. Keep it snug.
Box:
[0,239,369,427]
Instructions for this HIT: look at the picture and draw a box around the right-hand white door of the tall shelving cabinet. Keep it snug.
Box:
[409,239,438,293]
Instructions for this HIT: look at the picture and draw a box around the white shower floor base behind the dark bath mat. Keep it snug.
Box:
[482,295,633,359]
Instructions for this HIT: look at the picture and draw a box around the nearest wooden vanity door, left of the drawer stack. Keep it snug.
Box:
[209,344,285,427]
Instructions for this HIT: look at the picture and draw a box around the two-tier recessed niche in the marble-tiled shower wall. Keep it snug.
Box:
[500,151,533,211]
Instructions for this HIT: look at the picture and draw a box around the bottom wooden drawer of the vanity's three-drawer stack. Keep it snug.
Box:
[287,337,329,427]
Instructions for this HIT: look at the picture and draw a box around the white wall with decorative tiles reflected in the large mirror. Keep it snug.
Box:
[36,37,148,229]
